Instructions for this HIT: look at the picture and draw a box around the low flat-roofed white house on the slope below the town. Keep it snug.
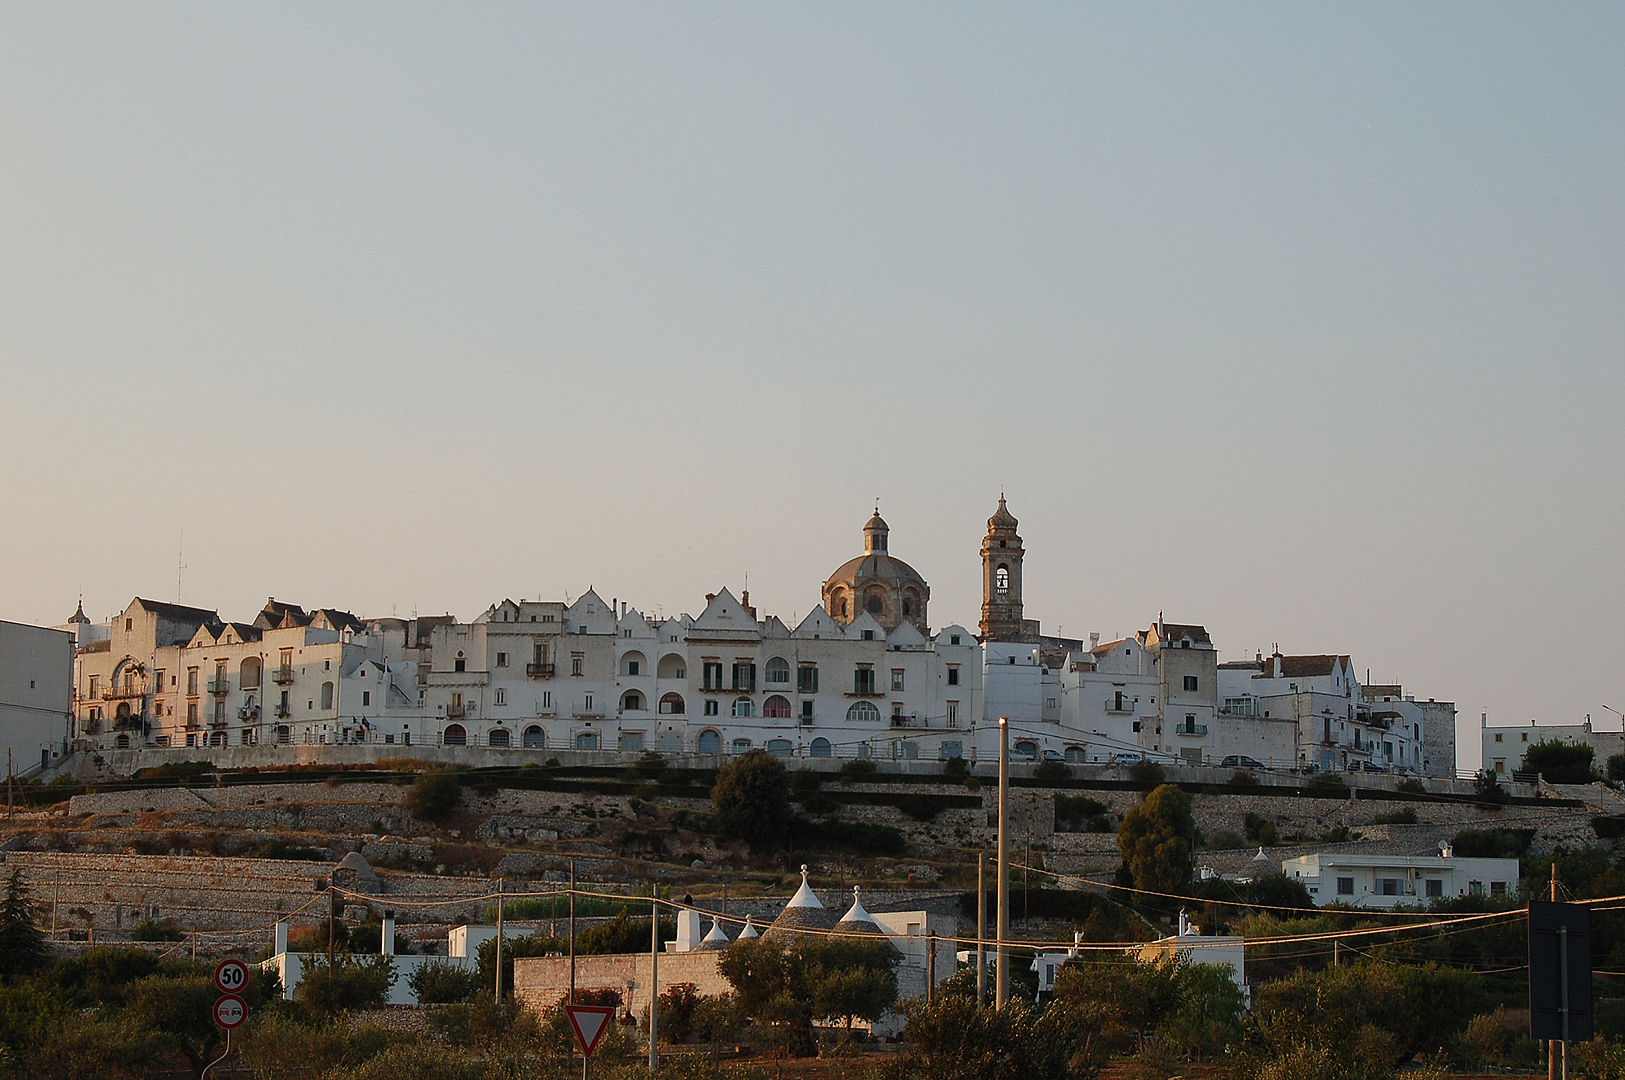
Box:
[1281,845,1518,908]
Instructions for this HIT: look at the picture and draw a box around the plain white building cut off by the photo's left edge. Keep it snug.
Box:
[0,620,73,773]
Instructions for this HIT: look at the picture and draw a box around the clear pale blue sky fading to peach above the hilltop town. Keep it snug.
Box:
[0,0,1625,763]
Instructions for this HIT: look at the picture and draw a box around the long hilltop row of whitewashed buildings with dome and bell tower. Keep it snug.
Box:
[68,499,1454,776]
